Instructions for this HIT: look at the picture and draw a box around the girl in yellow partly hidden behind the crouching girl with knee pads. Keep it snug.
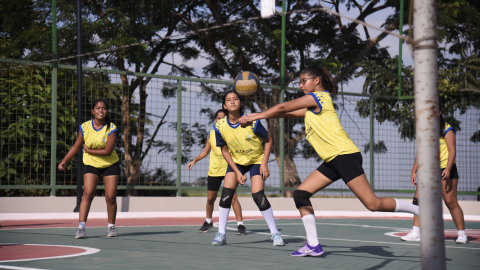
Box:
[187,110,247,235]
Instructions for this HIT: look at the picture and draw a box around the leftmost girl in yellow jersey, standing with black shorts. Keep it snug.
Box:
[58,99,120,238]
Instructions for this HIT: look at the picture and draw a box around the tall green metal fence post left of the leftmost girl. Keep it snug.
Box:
[50,0,57,197]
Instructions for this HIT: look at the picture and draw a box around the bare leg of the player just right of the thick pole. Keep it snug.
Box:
[442,179,465,230]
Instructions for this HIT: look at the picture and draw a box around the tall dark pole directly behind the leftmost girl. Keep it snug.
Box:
[74,0,83,212]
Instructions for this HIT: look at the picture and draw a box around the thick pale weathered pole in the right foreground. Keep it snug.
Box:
[413,0,446,270]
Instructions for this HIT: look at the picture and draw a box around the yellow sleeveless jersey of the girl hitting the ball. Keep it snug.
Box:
[305,91,360,162]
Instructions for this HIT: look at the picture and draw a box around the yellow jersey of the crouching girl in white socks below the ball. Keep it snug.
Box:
[213,116,268,166]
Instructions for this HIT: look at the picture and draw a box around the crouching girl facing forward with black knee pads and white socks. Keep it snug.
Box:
[212,91,285,246]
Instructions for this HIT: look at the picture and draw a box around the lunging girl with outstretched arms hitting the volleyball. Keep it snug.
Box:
[240,66,418,257]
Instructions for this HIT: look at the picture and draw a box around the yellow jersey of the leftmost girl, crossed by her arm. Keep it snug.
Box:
[80,120,120,169]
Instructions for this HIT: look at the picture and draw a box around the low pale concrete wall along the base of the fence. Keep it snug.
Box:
[0,197,480,215]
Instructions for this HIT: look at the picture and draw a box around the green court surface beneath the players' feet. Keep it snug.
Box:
[0,219,480,270]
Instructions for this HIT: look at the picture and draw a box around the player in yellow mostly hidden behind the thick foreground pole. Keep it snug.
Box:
[400,110,468,244]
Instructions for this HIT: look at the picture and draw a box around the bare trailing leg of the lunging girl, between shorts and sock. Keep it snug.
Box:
[347,174,397,212]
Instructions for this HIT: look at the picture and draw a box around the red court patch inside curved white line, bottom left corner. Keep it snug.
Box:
[0,244,85,262]
